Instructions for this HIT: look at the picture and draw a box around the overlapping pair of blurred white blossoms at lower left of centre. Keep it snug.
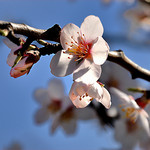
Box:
[35,79,96,134]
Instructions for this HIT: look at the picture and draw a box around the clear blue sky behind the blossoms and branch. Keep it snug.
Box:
[0,0,150,150]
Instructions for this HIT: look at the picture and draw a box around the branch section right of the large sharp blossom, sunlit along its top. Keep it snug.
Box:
[107,50,150,81]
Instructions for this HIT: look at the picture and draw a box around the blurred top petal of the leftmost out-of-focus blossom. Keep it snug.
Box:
[48,79,64,100]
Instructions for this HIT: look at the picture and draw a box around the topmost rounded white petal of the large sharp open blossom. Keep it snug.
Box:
[81,15,104,43]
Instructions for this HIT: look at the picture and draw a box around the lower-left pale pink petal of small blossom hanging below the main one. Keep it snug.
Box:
[72,96,91,108]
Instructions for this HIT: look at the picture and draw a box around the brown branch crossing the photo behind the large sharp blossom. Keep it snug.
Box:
[0,21,150,82]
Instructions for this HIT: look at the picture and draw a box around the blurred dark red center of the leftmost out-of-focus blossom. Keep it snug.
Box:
[48,100,61,113]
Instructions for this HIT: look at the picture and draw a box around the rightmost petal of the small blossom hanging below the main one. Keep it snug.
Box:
[96,87,111,109]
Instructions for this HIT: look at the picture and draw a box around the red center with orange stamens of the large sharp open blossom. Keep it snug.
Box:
[66,32,92,61]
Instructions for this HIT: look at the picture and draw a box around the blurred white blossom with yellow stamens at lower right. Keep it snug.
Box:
[111,88,150,150]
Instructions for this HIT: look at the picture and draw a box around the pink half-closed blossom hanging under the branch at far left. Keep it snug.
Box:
[4,39,40,78]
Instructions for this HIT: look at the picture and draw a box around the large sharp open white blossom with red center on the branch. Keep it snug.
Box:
[50,15,109,84]
